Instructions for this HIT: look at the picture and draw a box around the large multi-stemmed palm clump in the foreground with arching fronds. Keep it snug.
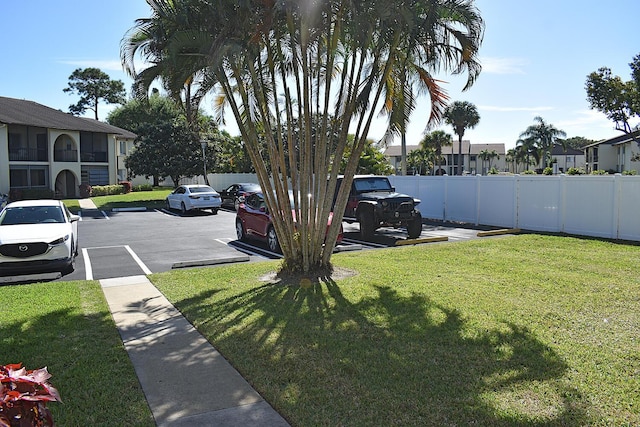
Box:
[121,0,483,274]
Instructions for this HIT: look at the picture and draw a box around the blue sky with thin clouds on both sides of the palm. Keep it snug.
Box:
[0,0,640,148]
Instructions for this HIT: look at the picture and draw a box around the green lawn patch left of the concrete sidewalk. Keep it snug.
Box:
[0,281,155,427]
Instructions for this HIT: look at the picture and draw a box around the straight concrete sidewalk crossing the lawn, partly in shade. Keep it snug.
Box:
[100,276,289,427]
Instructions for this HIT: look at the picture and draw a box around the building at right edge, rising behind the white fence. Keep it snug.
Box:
[584,130,640,173]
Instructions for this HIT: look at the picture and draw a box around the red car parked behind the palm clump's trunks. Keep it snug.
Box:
[236,191,342,252]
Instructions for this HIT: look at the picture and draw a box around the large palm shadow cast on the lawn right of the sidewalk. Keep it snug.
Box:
[171,279,594,426]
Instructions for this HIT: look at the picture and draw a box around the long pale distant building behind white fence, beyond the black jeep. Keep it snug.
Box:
[384,140,507,175]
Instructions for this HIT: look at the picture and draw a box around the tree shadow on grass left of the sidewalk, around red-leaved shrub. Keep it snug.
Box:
[0,308,155,426]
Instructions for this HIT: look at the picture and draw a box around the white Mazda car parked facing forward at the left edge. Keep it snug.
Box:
[0,200,80,276]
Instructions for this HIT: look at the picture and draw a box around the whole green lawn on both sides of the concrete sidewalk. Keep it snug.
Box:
[0,235,640,426]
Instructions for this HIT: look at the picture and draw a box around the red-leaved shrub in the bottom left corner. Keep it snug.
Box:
[0,364,62,427]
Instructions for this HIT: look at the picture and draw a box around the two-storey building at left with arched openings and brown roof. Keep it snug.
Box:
[0,97,136,198]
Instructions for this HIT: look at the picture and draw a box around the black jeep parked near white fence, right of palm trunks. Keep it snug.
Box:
[336,175,422,239]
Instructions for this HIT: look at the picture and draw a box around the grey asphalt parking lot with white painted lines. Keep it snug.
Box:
[0,210,510,283]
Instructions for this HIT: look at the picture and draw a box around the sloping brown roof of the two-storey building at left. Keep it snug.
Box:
[0,96,136,138]
